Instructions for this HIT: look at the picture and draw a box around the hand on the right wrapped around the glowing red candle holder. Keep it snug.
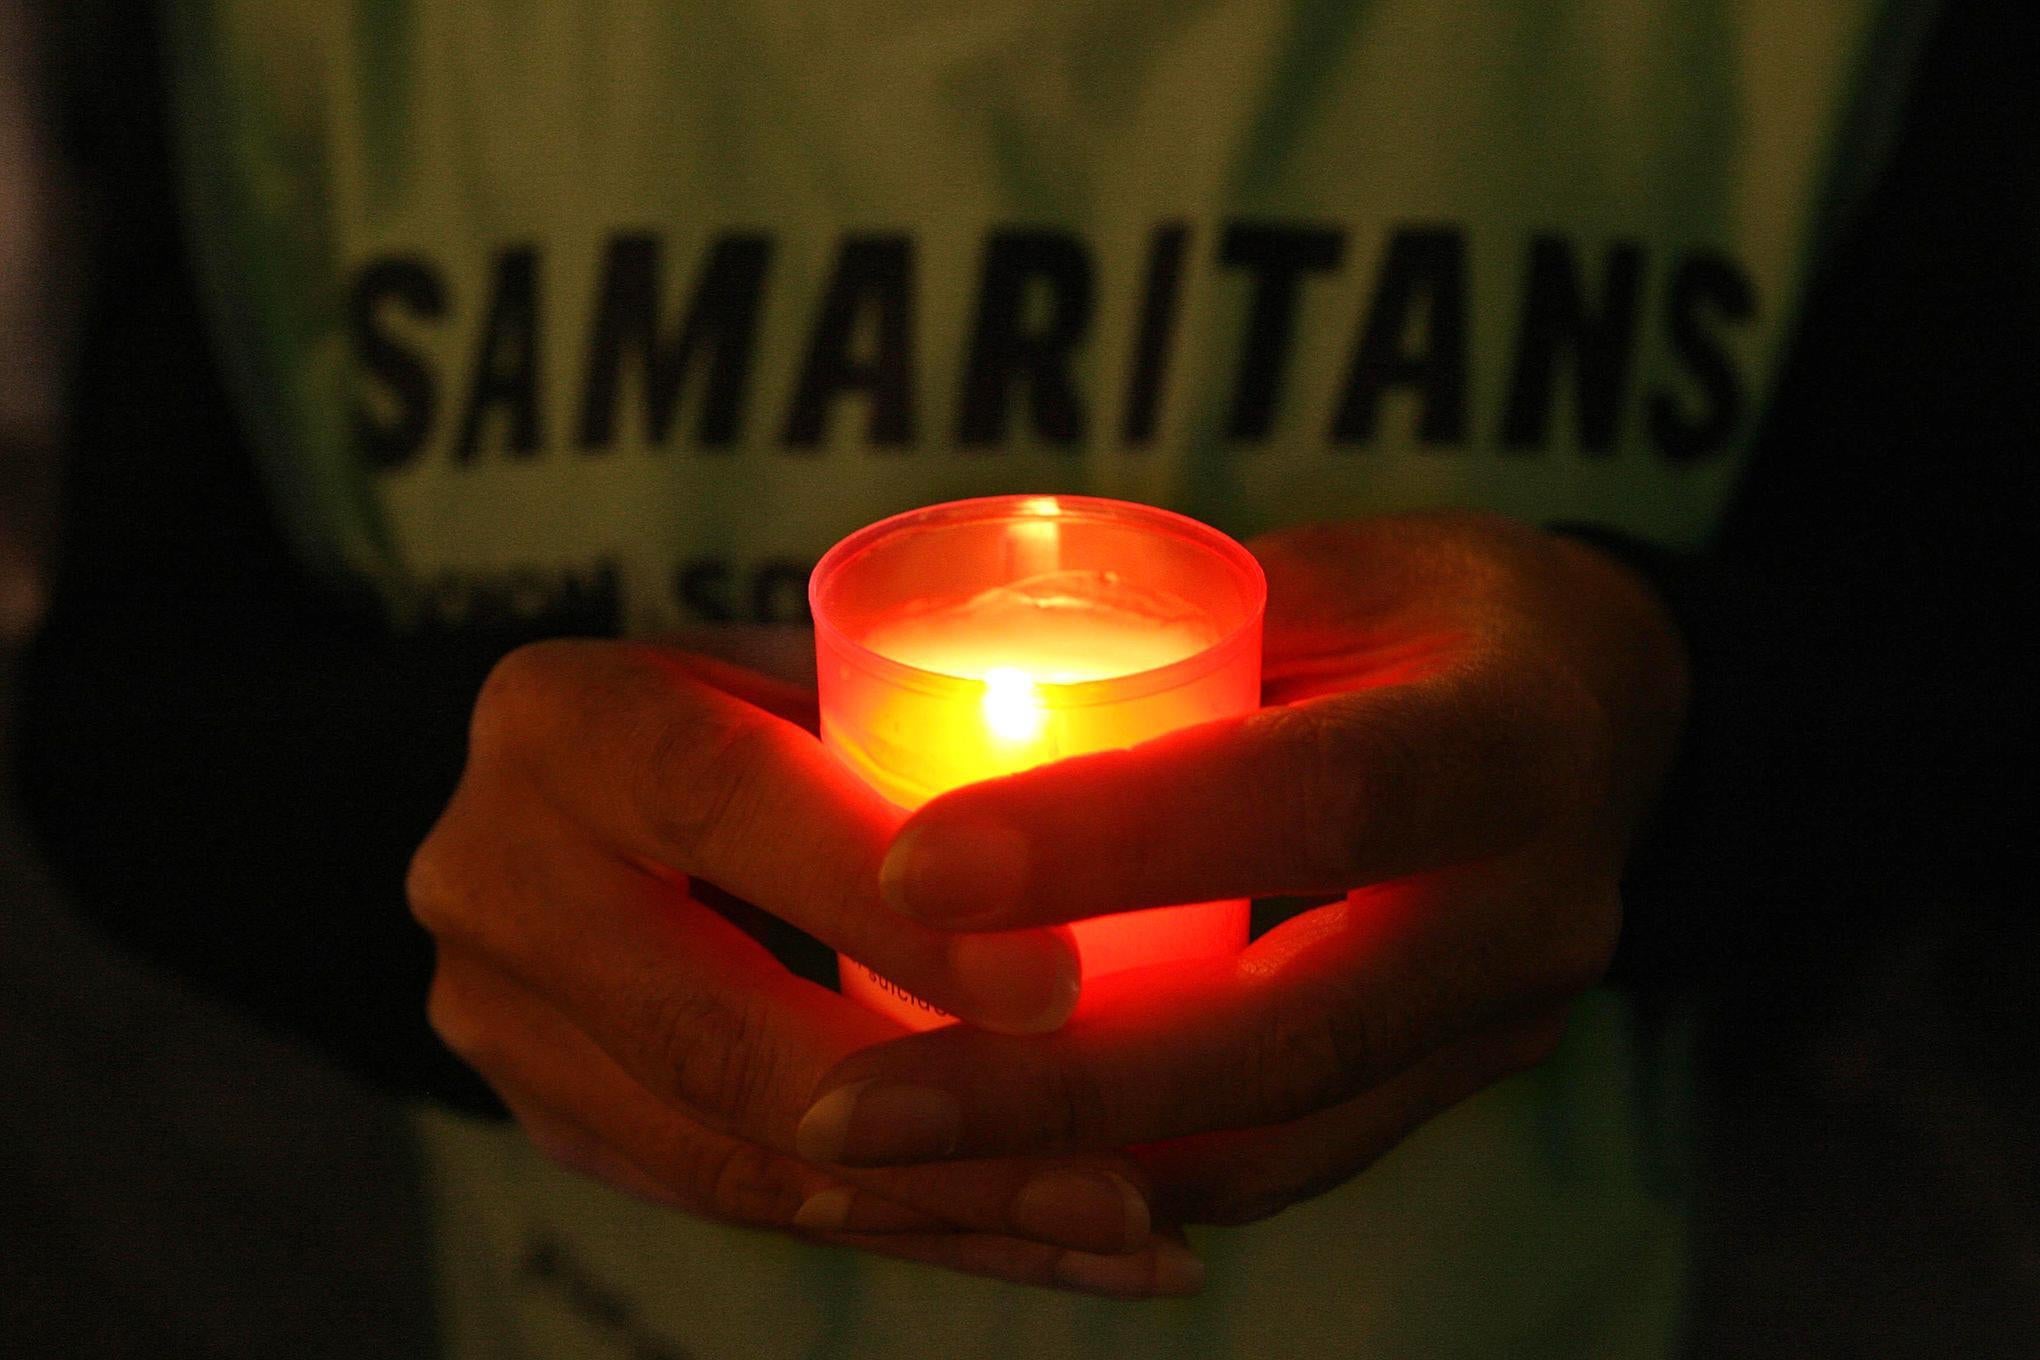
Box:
[796,514,1685,1223]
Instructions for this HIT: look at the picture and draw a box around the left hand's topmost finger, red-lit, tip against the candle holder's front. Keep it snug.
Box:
[452,642,1077,1034]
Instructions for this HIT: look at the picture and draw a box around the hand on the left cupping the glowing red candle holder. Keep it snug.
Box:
[408,642,1195,1295]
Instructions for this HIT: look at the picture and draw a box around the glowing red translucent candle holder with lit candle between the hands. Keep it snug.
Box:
[808,495,1267,1028]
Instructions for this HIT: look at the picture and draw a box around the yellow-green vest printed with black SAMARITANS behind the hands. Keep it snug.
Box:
[155,0,1924,1356]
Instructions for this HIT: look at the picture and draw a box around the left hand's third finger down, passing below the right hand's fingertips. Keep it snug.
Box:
[432,952,1151,1252]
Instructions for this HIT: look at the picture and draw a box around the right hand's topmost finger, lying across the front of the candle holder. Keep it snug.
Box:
[881,657,1595,930]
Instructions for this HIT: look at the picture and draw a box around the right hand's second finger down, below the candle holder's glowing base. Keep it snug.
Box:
[796,867,1616,1166]
